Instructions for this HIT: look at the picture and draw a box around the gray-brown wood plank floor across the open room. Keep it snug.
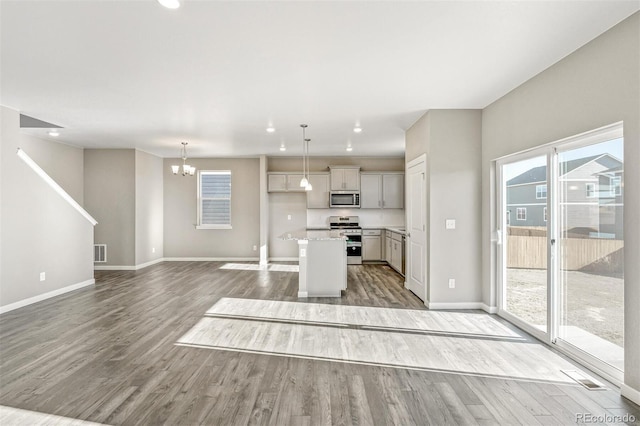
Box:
[0,262,640,425]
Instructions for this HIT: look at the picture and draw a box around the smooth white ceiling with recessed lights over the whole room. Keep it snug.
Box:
[0,0,640,157]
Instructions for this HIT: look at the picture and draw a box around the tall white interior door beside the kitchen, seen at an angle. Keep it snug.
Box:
[405,155,428,301]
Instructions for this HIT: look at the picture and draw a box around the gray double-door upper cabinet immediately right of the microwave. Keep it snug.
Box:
[360,173,404,209]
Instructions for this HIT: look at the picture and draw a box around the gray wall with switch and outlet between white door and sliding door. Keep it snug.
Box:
[406,110,482,304]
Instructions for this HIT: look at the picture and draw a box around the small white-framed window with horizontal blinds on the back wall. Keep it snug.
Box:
[196,170,231,229]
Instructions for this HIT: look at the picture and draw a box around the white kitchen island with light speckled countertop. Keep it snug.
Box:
[280,230,347,297]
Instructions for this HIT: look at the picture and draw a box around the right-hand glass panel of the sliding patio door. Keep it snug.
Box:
[557,138,624,370]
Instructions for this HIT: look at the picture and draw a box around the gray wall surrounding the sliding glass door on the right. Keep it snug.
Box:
[482,13,640,391]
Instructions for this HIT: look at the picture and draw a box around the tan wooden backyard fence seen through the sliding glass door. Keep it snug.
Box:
[507,235,624,271]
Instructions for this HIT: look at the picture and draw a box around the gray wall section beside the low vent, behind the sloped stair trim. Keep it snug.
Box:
[84,149,136,267]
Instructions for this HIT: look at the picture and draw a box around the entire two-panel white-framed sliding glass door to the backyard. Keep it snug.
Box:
[496,125,624,379]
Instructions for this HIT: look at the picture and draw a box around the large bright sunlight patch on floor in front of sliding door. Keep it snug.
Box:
[176,298,575,383]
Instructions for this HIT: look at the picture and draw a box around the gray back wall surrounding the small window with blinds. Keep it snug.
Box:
[163,158,260,260]
